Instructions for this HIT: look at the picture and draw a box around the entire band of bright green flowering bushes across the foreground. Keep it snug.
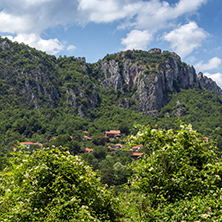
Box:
[0,123,222,221]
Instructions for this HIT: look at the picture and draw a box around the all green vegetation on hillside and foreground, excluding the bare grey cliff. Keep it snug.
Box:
[0,38,222,221]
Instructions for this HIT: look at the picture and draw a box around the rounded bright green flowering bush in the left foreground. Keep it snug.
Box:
[0,148,119,221]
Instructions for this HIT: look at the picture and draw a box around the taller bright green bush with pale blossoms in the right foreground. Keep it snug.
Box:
[126,123,222,221]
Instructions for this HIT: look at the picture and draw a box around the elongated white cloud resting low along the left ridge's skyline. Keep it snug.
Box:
[7,33,64,54]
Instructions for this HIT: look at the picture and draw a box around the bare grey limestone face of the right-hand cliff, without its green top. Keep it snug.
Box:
[97,49,199,116]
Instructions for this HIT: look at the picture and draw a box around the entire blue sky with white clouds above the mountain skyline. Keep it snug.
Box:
[0,0,222,88]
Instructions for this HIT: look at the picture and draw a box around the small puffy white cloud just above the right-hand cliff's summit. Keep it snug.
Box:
[121,30,153,50]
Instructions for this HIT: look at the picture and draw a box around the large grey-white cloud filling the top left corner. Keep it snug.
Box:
[0,0,78,34]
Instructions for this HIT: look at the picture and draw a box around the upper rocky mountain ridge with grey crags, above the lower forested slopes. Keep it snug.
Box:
[0,38,222,117]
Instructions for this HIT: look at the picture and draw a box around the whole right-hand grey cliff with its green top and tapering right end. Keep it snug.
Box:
[99,48,222,115]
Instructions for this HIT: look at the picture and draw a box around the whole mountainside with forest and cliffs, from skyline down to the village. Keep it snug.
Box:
[0,38,222,152]
